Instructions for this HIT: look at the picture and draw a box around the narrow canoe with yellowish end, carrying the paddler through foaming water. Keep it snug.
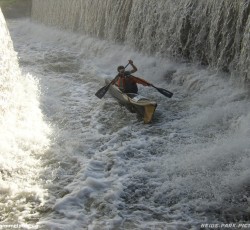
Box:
[105,79,157,124]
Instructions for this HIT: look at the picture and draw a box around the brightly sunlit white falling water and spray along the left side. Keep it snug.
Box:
[0,11,49,224]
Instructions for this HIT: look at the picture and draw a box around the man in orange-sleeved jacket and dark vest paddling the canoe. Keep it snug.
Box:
[112,60,150,93]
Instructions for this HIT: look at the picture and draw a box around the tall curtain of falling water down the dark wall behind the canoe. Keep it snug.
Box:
[32,0,250,81]
